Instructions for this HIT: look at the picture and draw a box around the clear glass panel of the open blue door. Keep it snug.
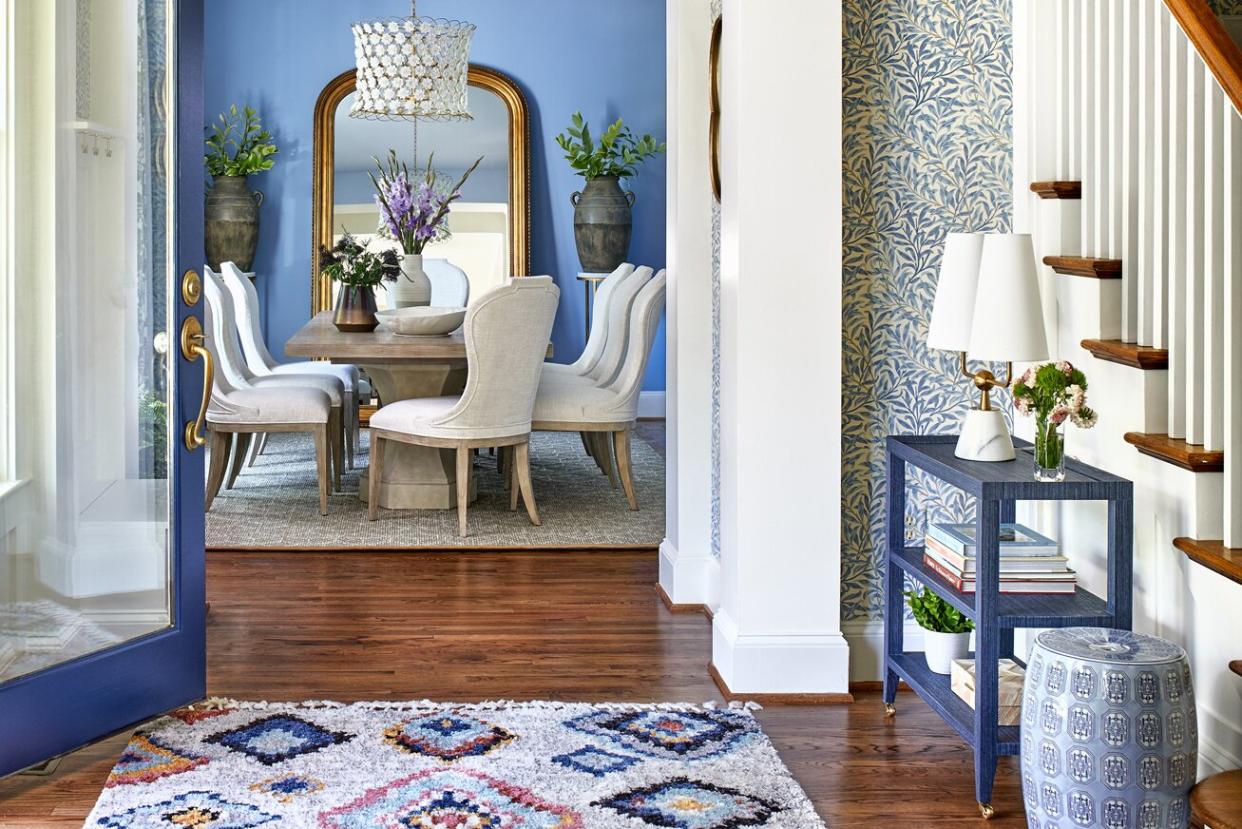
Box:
[0,0,176,682]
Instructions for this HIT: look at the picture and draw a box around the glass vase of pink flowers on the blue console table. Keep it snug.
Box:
[1013,360,1099,482]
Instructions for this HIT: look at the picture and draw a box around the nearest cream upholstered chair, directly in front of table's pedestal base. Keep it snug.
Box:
[368,276,560,538]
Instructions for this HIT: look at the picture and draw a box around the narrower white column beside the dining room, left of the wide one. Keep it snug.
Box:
[660,0,718,605]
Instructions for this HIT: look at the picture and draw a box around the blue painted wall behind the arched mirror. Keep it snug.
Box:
[204,0,666,390]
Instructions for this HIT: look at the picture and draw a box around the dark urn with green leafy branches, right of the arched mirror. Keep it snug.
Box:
[556,112,664,273]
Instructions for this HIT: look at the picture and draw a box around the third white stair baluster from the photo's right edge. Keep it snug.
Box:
[1165,19,1190,439]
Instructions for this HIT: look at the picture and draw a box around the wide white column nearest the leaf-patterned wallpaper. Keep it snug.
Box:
[712,0,848,694]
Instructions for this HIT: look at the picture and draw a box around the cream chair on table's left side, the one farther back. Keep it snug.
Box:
[220,262,363,469]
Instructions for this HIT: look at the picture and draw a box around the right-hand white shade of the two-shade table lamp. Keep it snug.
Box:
[968,234,1048,363]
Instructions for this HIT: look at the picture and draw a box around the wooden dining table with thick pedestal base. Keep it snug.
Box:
[284,311,551,510]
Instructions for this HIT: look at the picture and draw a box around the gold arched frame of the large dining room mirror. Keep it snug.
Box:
[311,63,530,313]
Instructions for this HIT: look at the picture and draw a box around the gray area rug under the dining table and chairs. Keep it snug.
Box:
[207,429,664,549]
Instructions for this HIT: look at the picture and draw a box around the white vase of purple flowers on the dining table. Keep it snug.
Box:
[371,149,483,308]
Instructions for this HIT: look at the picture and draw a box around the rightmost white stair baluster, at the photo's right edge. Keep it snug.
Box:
[1221,102,1242,547]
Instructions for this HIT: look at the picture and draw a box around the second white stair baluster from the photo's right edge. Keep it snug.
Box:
[1182,47,1207,444]
